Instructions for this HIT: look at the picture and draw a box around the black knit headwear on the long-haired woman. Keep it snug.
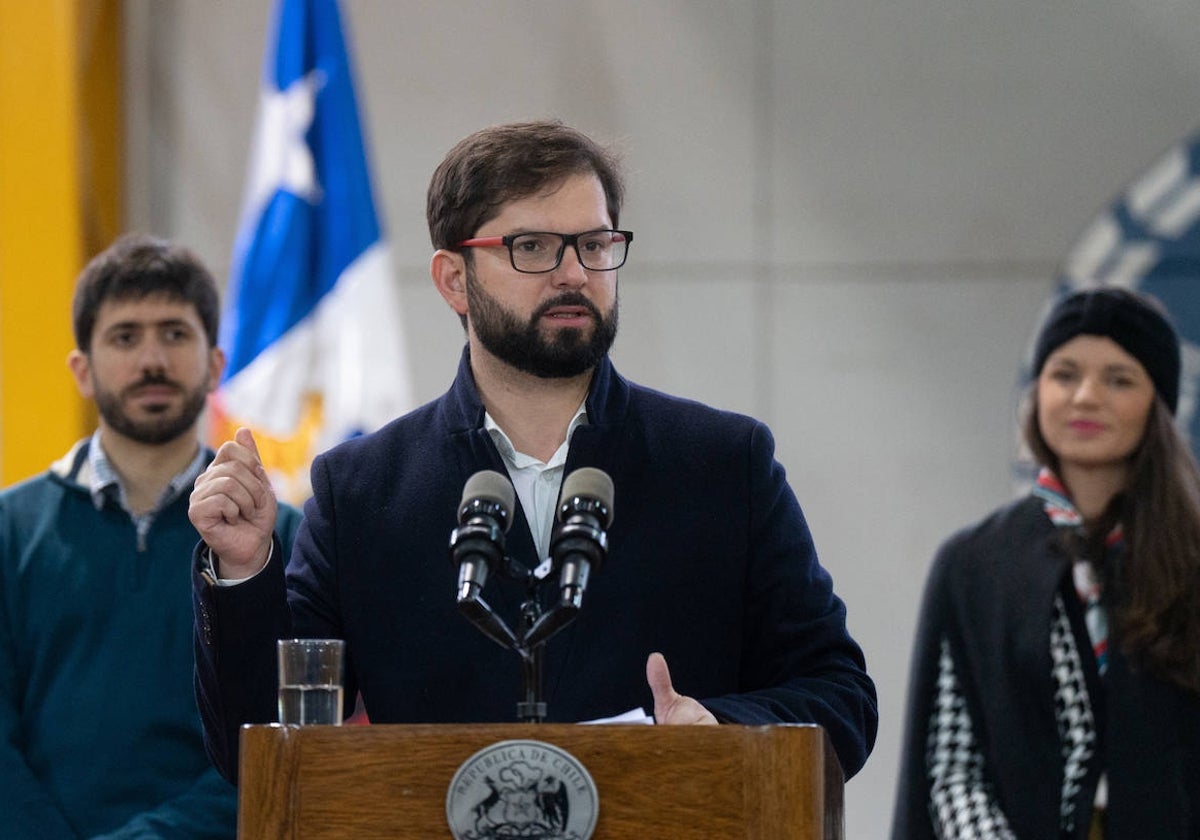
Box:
[1033,286,1180,414]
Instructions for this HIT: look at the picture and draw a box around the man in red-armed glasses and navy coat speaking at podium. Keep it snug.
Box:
[191,122,878,779]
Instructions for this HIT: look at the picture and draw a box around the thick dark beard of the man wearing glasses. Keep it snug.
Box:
[467,268,619,379]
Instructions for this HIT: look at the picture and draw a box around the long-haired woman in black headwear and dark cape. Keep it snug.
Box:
[892,287,1200,840]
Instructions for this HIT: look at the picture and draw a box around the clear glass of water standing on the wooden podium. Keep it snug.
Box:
[278,638,346,726]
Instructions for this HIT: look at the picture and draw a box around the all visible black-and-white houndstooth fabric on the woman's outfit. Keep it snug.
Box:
[926,596,1096,840]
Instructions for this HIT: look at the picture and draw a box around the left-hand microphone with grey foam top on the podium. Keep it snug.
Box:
[450,469,517,647]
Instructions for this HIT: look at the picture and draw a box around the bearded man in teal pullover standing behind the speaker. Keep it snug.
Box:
[0,236,299,840]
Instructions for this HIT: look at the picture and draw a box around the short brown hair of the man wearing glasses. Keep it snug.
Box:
[425,120,625,250]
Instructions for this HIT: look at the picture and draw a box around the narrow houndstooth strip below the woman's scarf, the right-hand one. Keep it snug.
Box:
[1050,595,1096,833]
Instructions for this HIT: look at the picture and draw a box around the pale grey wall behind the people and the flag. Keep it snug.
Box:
[119,0,1200,839]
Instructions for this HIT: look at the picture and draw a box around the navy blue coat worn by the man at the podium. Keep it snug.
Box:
[194,353,878,779]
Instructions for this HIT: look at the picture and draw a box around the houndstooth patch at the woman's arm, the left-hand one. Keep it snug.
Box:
[925,638,1015,840]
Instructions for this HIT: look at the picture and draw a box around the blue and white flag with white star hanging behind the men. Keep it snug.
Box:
[210,0,412,504]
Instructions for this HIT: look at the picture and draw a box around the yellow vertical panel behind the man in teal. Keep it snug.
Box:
[0,0,121,486]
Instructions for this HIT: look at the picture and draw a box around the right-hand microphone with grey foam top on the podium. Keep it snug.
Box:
[522,467,613,649]
